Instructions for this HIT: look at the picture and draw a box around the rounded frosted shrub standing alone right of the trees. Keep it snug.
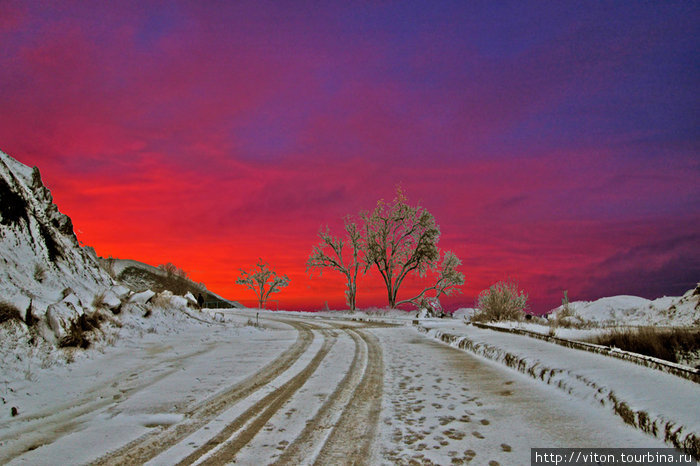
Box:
[472,281,527,322]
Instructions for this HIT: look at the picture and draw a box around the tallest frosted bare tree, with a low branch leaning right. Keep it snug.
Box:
[360,187,464,308]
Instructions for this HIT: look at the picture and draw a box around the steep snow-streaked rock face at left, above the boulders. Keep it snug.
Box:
[0,152,114,326]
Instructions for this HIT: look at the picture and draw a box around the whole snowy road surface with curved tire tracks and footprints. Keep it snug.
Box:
[0,311,664,465]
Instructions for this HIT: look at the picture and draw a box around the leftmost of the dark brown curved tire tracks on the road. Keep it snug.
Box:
[93,319,314,465]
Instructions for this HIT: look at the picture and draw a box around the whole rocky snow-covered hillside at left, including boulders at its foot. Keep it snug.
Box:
[0,152,242,354]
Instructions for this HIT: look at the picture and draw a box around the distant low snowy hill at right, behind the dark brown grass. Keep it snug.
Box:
[549,284,700,327]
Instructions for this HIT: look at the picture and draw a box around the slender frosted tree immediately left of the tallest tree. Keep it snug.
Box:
[306,218,362,311]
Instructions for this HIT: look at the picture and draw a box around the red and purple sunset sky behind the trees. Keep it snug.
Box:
[0,1,700,312]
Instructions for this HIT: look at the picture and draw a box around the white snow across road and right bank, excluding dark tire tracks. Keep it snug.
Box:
[0,306,699,464]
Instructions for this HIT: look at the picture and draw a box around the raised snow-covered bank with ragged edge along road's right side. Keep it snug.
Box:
[419,325,700,457]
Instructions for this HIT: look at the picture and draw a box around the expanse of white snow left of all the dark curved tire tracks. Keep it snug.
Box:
[0,301,296,464]
